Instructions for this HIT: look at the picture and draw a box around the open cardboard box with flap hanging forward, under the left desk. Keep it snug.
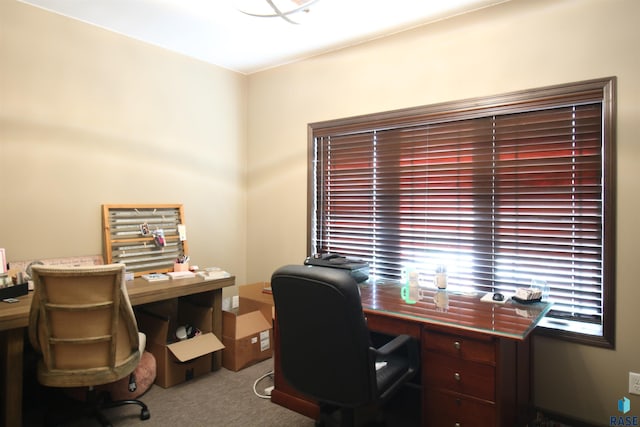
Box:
[136,300,224,388]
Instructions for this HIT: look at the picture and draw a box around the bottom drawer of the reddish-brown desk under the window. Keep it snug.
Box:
[423,389,497,427]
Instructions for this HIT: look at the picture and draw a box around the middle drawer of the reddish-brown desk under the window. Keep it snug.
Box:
[423,351,495,402]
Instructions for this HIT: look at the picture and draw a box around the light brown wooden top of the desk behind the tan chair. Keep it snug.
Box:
[0,276,235,331]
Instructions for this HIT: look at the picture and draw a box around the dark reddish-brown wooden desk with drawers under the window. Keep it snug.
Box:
[271,283,551,427]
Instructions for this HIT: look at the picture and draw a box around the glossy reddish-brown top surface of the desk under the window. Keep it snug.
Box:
[360,282,551,340]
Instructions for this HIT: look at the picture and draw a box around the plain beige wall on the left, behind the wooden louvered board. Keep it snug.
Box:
[0,0,247,283]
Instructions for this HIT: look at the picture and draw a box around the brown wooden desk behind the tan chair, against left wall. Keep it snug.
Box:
[0,276,235,427]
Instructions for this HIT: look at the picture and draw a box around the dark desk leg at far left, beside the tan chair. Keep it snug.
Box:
[0,328,24,427]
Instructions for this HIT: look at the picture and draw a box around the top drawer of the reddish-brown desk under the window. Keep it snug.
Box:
[423,329,496,365]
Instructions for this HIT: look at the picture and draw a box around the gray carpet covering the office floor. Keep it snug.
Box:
[23,359,420,427]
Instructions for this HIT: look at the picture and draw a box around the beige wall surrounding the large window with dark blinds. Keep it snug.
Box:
[247,0,640,425]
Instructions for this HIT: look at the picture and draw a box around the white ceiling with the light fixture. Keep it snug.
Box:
[21,0,509,74]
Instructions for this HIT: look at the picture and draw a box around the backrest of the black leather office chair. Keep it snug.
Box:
[271,265,375,407]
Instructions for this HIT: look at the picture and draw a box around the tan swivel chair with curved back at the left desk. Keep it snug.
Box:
[29,264,149,425]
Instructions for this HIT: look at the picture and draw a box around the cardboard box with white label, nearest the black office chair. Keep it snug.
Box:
[222,286,273,371]
